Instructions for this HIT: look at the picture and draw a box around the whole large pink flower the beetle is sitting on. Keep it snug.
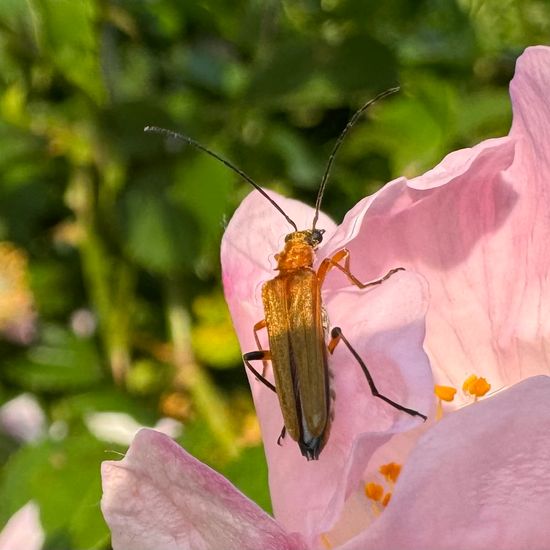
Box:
[102,47,550,550]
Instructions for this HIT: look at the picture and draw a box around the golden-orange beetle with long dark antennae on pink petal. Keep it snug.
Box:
[145,88,427,461]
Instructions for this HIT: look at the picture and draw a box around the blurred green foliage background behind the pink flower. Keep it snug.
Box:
[0,0,550,550]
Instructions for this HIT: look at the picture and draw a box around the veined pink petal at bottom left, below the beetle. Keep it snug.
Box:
[101,429,304,550]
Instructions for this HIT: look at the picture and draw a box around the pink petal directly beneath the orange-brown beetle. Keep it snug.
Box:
[222,194,433,541]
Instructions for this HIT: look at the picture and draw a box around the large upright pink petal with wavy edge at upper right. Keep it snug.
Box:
[327,47,550,396]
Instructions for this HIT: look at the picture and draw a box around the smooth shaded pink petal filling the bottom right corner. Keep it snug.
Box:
[348,376,550,550]
